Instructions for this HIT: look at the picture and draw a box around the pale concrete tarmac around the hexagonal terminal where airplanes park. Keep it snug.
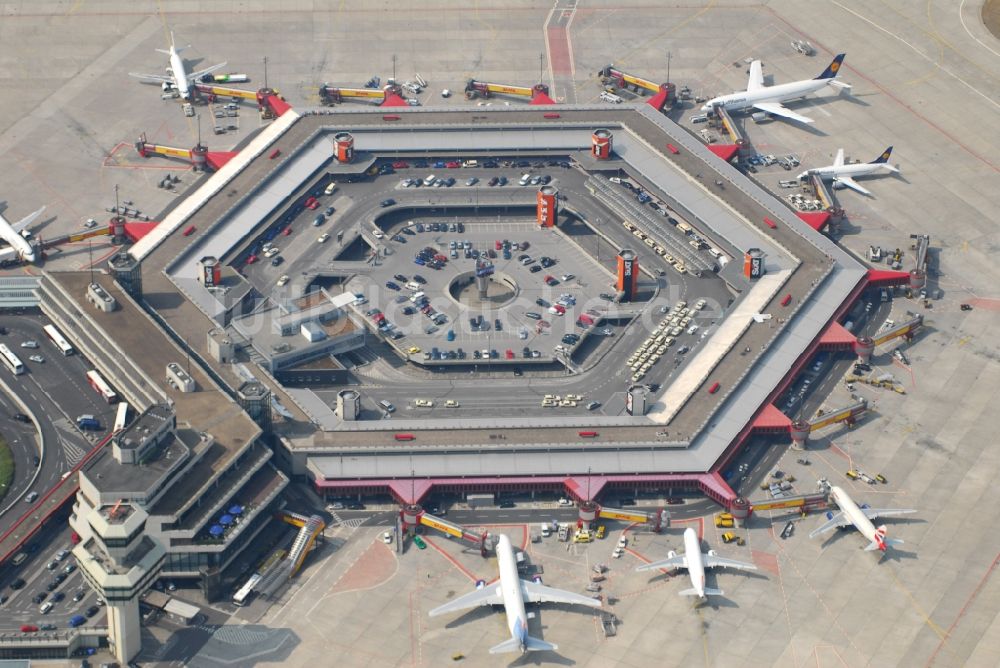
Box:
[0,0,1000,666]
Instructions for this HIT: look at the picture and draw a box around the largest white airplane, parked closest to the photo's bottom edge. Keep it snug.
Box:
[430,534,601,654]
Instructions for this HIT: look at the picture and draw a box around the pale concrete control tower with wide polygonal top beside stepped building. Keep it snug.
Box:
[73,501,166,664]
